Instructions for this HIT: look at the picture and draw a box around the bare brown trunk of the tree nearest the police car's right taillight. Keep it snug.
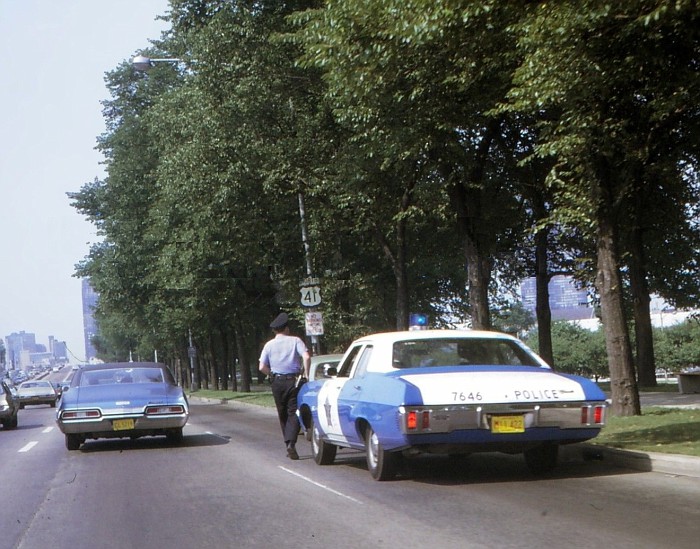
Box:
[594,178,641,416]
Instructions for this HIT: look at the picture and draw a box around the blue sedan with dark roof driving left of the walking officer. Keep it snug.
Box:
[56,362,190,450]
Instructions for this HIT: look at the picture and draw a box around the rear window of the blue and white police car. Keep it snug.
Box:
[393,338,541,368]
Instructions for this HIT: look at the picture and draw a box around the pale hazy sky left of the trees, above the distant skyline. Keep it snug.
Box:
[0,0,169,362]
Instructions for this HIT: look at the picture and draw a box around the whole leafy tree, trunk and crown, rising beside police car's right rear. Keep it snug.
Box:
[510,0,698,415]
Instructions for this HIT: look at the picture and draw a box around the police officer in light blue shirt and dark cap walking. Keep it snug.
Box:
[258,313,311,459]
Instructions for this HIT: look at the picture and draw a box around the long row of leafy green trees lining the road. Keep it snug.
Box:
[71,0,700,414]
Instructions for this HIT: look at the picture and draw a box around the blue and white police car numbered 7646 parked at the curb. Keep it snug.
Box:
[297,330,607,480]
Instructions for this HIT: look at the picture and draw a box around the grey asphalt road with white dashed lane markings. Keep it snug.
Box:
[0,398,700,549]
